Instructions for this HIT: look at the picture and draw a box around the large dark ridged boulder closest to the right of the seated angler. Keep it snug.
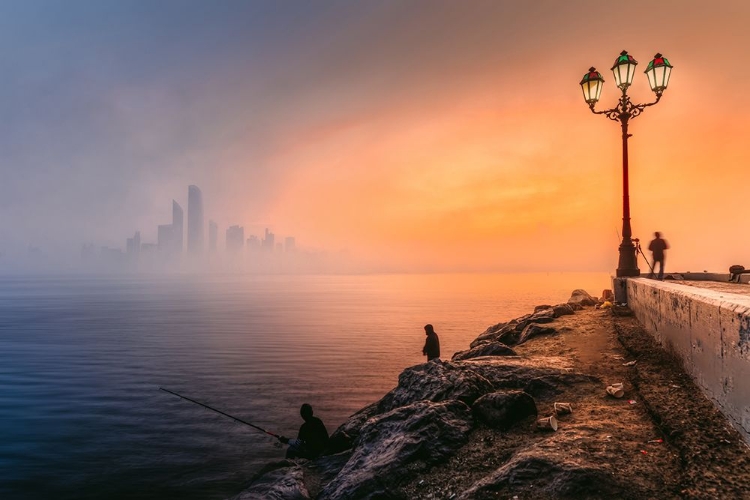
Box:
[320,400,473,500]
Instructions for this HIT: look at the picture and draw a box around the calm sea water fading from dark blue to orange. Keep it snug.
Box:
[0,273,610,499]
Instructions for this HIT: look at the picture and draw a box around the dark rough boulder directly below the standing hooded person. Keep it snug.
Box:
[378,361,495,413]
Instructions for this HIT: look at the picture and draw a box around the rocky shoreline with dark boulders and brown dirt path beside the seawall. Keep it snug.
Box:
[233,290,750,500]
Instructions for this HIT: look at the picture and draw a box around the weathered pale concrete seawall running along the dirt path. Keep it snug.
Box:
[627,278,750,444]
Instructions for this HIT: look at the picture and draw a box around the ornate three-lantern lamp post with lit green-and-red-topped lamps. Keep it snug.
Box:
[581,50,672,277]
